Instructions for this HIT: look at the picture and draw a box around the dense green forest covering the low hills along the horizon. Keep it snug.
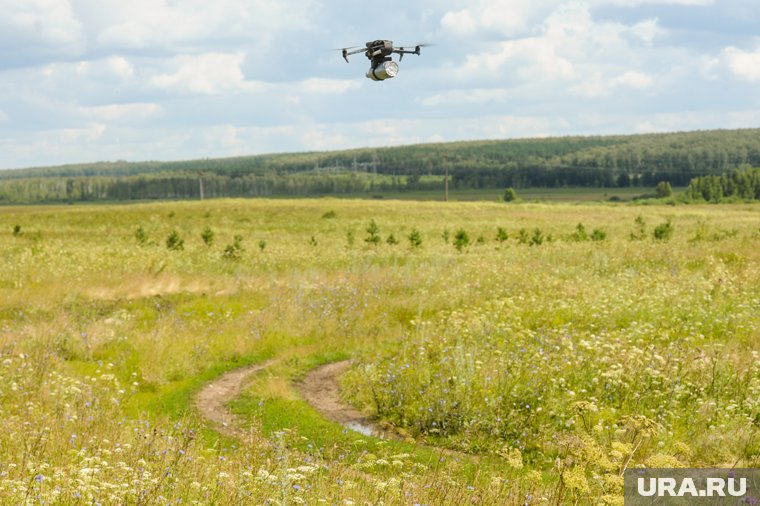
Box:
[0,129,760,203]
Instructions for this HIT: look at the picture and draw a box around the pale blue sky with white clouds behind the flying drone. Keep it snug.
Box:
[0,0,760,168]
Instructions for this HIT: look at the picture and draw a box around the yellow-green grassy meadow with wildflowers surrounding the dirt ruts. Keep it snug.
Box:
[0,200,760,505]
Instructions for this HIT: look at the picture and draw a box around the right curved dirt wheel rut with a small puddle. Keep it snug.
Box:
[295,360,397,439]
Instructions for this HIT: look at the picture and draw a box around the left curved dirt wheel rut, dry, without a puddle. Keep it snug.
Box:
[195,360,274,438]
